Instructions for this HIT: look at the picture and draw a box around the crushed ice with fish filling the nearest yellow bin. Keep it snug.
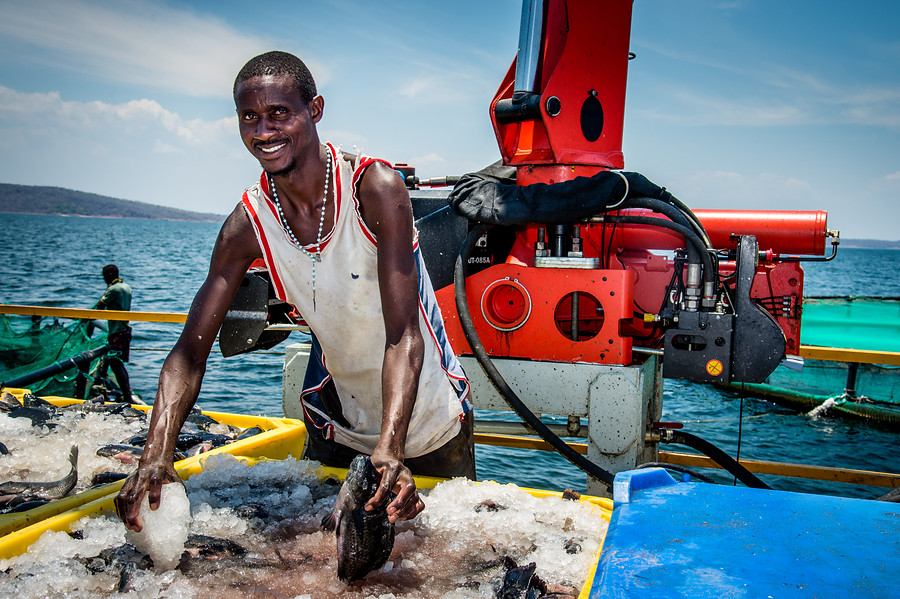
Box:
[0,454,607,599]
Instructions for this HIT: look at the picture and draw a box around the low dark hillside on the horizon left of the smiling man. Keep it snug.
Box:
[0,183,225,222]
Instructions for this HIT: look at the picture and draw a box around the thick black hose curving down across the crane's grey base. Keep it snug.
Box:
[453,225,613,487]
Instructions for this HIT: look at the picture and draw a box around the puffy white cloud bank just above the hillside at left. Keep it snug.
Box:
[0,86,259,213]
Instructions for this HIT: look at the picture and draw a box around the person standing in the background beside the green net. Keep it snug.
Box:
[94,264,134,403]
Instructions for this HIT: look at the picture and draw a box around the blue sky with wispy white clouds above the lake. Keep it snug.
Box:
[0,0,900,240]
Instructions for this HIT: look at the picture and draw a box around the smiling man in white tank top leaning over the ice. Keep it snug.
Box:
[116,52,475,530]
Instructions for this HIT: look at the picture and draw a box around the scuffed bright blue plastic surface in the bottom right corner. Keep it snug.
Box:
[590,468,900,599]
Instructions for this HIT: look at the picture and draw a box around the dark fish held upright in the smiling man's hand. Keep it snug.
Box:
[322,454,394,582]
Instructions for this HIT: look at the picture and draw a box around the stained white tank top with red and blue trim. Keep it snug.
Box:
[242,144,472,458]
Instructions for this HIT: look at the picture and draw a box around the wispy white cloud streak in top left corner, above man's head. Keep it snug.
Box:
[0,0,327,97]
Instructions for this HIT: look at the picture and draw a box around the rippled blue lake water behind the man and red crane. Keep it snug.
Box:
[0,214,900,497]
